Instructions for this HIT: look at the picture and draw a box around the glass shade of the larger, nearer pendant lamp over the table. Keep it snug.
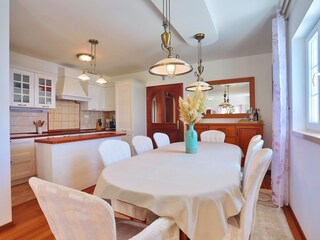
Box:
[149,57,192,78]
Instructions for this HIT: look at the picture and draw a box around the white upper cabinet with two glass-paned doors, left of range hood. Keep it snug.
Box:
[10,68,56,108]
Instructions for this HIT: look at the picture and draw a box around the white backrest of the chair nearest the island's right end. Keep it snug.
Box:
[99,140,131,167]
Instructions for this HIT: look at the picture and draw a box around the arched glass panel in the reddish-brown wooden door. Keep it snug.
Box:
[152,91,176,123]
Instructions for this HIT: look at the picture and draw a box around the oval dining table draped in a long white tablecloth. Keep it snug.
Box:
[94,142,245,240]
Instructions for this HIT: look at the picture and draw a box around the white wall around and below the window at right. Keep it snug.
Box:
[287,0,320,240]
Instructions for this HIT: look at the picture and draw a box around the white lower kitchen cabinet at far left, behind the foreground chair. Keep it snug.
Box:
[10,138,36,185]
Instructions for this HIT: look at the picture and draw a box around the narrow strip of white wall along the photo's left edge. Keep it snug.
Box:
[0,0,12,226]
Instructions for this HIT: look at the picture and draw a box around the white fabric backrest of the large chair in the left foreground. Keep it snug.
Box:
[29,177,116,240]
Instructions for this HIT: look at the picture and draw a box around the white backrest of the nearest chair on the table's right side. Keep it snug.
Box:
[240,148,273,239]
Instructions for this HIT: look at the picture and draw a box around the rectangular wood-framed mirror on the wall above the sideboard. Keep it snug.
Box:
[204,77,255,118]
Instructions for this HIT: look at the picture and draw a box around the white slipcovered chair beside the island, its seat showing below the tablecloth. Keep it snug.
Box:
[99,140,154,222]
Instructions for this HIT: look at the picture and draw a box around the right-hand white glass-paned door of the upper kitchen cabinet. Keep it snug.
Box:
[35,74,56,108]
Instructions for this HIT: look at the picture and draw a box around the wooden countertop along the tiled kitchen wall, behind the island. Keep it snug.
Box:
[10,129,115,139]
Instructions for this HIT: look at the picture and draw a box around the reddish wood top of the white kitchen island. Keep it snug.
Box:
[34,132,126,144]
